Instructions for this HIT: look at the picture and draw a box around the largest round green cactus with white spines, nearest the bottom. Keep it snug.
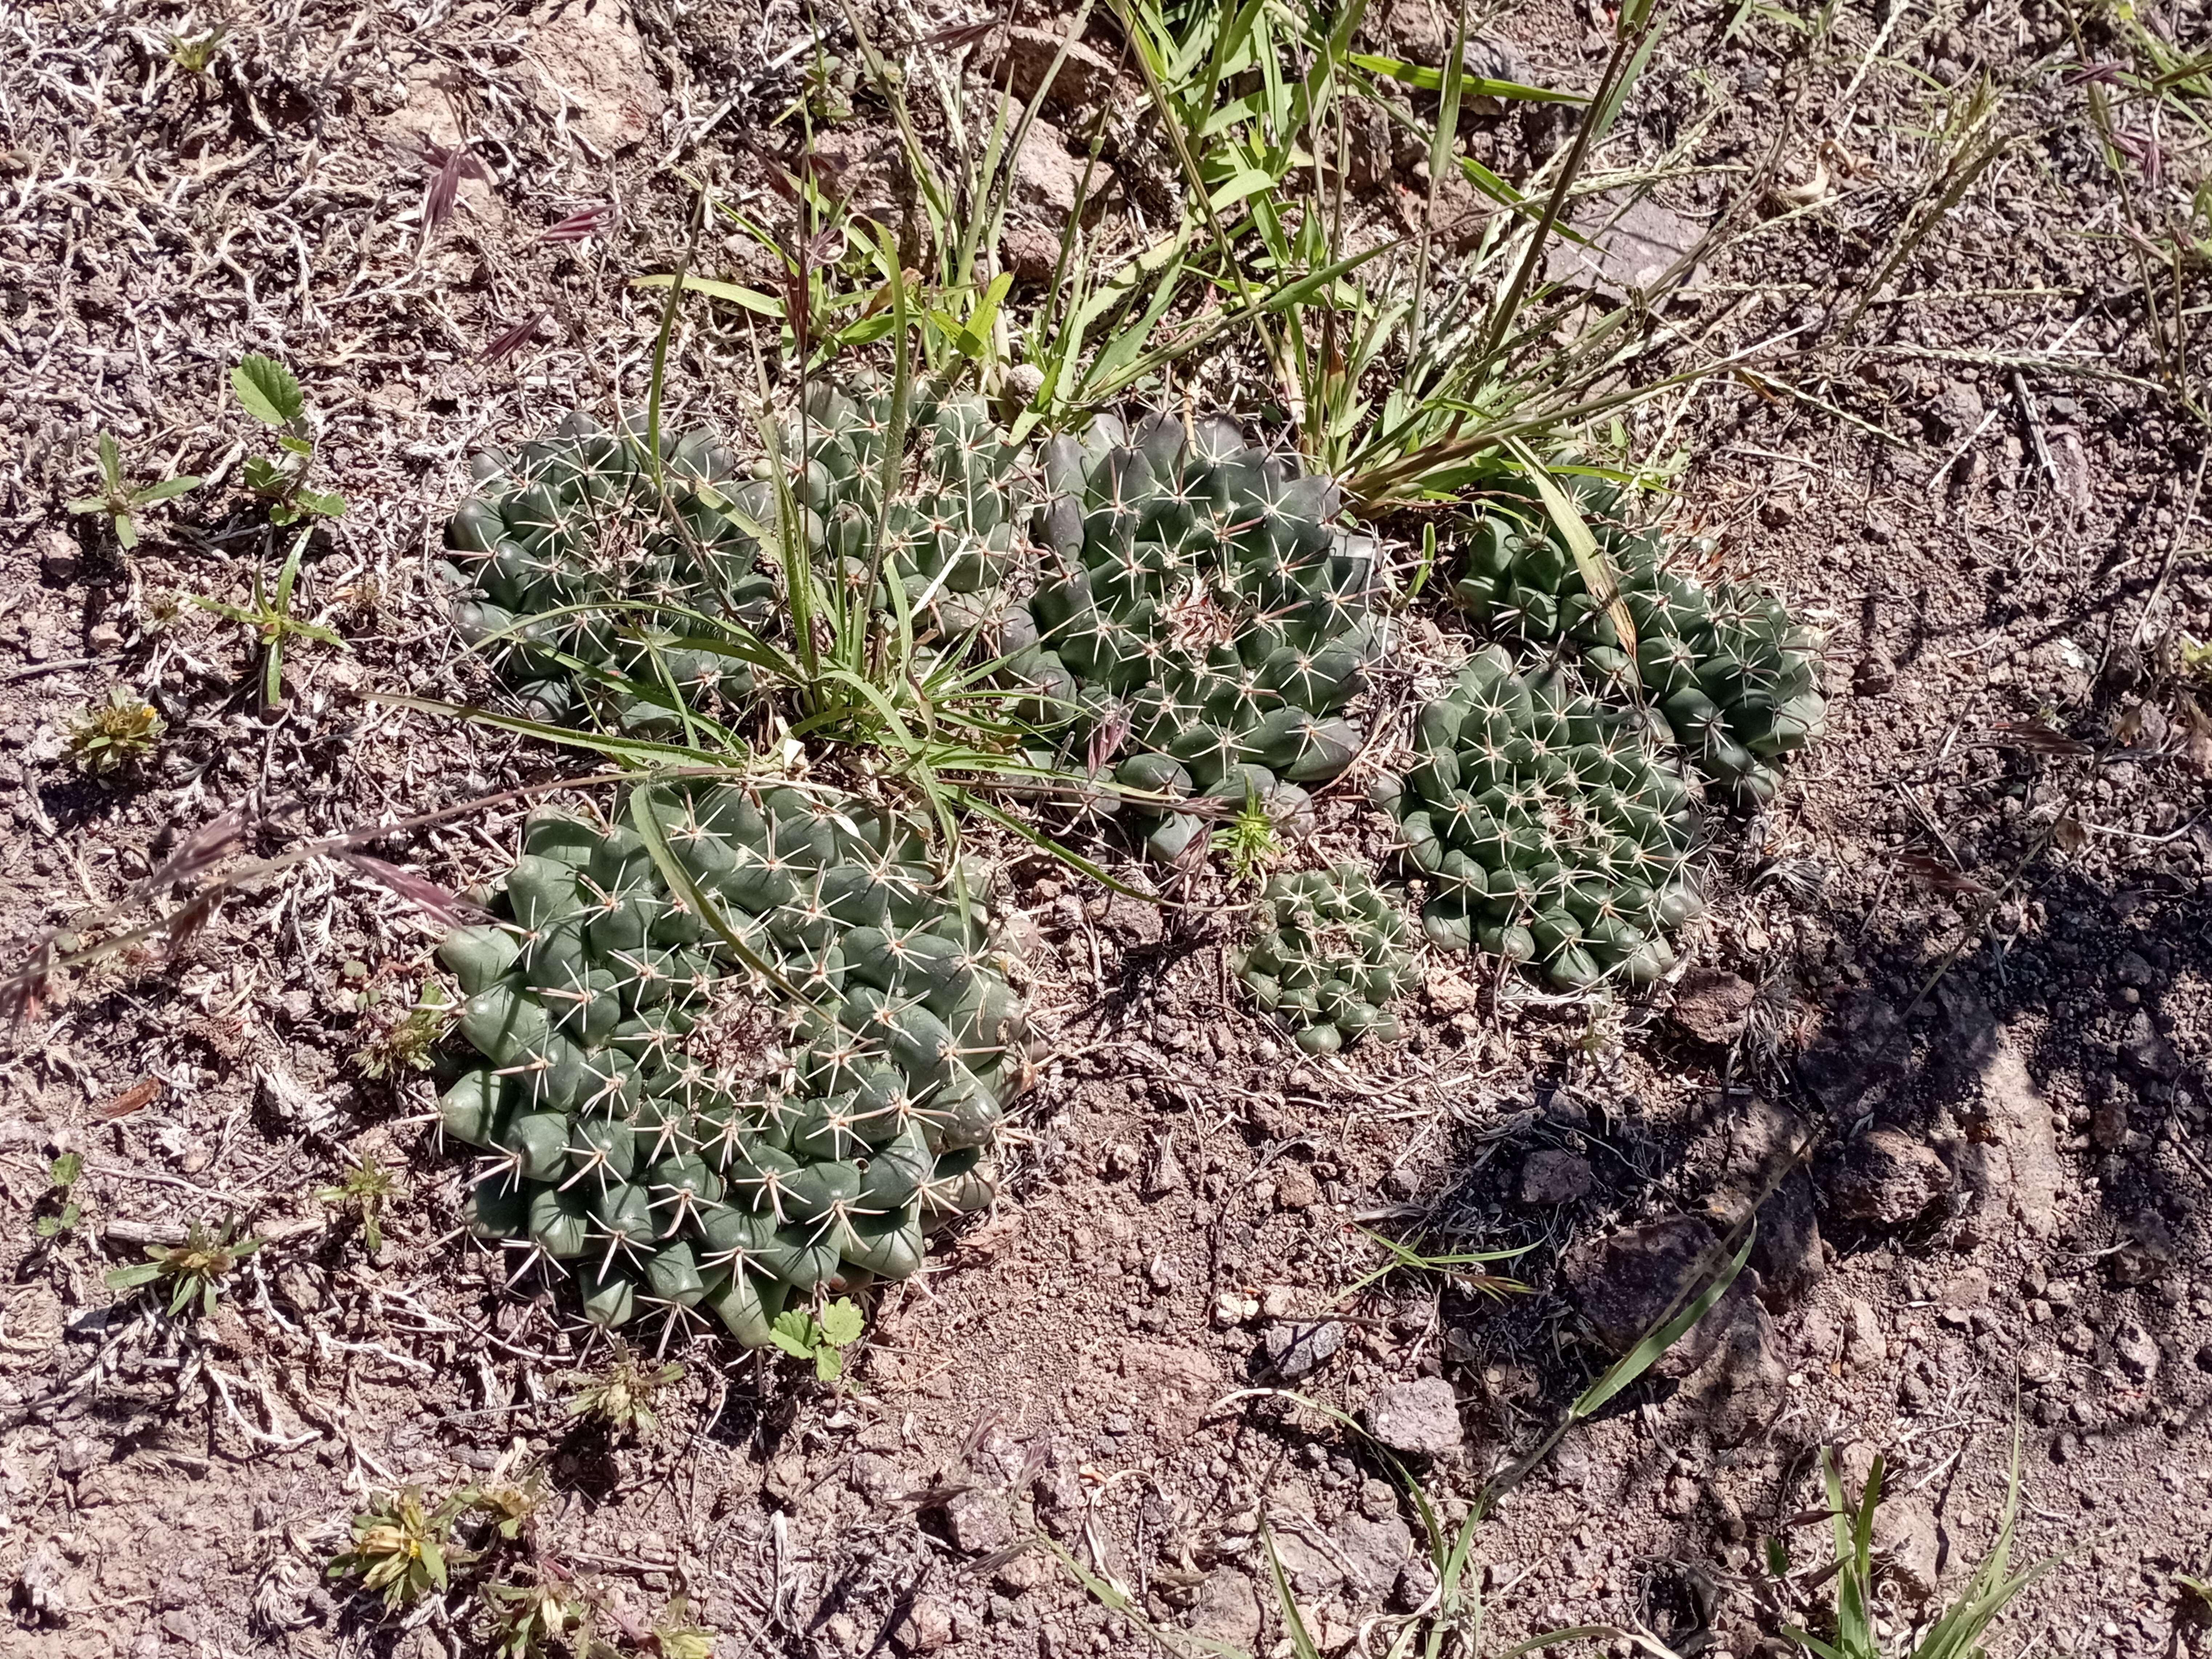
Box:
[440,785,1026,1345]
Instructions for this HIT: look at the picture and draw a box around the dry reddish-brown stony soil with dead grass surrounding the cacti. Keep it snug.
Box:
[0,0,2212,1659]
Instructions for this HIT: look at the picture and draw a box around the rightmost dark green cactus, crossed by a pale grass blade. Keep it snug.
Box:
[1453,487,1827,803]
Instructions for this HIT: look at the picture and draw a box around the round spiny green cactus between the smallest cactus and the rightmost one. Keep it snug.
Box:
[1374,646,1703,991]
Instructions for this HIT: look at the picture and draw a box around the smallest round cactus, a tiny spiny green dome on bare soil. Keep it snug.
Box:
[1234,865,1420,1055]
